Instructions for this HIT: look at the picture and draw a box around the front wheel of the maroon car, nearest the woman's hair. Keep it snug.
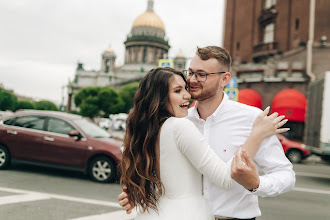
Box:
[89,157,116,183]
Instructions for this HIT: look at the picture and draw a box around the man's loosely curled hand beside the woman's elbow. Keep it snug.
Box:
[231,149,260,190]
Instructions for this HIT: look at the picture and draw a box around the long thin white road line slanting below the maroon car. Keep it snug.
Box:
[0,187,121,208]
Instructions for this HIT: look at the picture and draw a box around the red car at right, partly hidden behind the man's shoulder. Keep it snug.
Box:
[277,134,311,163]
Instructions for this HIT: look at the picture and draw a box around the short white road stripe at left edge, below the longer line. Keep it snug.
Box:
[0,193,50,205]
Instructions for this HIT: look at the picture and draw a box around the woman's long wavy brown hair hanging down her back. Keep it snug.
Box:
[120,67,186,212]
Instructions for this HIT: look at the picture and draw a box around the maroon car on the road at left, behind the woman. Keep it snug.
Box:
[0,110,122,182]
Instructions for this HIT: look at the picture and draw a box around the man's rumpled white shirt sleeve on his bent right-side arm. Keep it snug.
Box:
[253,135,296,197]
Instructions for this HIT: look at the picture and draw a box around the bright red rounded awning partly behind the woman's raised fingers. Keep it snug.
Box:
[272,89,307,122]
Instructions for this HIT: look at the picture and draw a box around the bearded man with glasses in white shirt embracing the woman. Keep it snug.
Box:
[118,46,295,219]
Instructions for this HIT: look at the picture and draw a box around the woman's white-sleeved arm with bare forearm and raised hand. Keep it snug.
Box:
[173,109,287,188]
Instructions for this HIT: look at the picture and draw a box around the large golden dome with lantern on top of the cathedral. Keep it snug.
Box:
[133,0,165,31]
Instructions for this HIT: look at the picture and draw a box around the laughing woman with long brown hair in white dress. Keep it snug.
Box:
[121,68,286,220]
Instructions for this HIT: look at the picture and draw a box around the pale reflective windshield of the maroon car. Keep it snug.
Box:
[74,119,110,138]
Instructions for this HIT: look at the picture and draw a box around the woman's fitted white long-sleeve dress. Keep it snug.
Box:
[135,117,233,220]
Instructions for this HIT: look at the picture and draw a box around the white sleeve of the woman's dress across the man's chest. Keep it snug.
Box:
[174,118,233,189]
